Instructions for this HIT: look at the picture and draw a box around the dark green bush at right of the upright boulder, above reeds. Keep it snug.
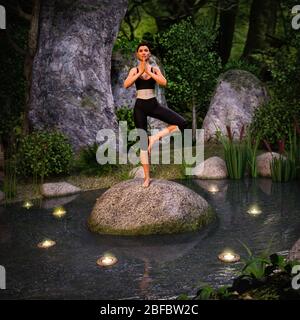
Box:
[250,98,297,145]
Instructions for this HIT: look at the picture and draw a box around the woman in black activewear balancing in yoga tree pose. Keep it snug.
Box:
[124,42,186,188]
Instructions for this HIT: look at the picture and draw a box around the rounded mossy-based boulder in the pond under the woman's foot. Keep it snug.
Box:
[88,179,214,235]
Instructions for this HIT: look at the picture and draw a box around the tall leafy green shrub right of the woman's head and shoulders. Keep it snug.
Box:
[158,19,221,118]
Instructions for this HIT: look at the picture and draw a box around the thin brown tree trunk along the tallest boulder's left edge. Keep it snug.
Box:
[22,0,41,135]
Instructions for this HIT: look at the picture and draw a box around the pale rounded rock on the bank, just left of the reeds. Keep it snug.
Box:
[193,157,227,179]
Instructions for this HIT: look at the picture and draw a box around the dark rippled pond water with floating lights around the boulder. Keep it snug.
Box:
[0,179,300,299]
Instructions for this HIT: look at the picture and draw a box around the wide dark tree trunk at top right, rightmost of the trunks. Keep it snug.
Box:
[242,0,278,58]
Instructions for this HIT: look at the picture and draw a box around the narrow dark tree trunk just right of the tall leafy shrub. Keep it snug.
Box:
[219,0,239,65]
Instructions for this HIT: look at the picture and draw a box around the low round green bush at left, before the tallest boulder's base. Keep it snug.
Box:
[18,131,74,177]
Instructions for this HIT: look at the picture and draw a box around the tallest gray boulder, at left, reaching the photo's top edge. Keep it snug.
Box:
[29,0,128,150]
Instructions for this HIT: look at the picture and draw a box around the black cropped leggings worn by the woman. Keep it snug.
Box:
[133,97,186,150]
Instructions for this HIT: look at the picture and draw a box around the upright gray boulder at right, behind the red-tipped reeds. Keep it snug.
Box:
[203,70,268,141]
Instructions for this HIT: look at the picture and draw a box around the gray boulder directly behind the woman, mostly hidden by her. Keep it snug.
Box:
[111,51,168,129]
